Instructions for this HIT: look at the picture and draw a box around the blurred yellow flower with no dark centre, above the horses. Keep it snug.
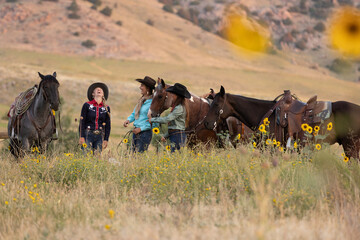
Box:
[224,13,269,53]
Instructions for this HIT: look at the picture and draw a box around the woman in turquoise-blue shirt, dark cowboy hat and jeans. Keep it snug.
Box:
[124,76,156,152]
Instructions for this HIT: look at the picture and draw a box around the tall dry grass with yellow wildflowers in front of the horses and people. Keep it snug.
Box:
[0,140,360,239]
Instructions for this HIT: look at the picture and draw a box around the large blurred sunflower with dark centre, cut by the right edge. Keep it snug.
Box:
[329,7,360,57]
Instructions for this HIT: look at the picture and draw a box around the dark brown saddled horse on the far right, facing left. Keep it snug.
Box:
[204,86,360,159]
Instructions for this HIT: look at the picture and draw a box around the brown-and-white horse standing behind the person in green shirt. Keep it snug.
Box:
[148,78,251,145]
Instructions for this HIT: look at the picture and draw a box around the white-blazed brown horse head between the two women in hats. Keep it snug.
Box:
[148,78,173,117]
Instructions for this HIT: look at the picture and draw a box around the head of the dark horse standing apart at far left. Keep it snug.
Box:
[39,72,60,111]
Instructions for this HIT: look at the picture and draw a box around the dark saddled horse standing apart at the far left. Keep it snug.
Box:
[8,72,60,158]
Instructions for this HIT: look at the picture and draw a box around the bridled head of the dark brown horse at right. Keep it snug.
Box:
[204,86,231,130]
